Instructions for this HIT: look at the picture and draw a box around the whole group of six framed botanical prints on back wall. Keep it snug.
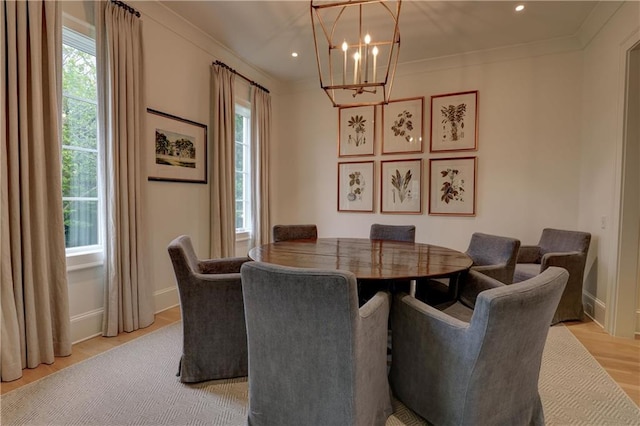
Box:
[337,90,479,216]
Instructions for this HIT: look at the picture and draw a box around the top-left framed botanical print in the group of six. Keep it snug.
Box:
[338,105,376,157]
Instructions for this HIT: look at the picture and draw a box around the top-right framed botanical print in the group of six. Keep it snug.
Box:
[429,90,478,152]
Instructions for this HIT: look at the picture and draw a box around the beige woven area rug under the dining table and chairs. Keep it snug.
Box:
[1,323,640,426]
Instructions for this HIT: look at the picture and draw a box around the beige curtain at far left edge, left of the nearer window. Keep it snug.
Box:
[0,0,71,381]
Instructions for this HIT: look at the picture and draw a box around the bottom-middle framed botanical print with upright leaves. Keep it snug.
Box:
[380,158,422,214]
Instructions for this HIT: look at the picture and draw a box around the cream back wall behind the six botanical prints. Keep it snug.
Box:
[273,51,582,250]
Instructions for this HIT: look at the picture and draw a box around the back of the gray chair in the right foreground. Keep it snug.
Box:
[464,267,569,424]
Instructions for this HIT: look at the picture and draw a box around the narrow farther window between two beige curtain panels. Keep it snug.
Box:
[235,104,251,234]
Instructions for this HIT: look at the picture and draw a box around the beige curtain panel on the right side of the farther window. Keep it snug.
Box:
[249,86,271,248]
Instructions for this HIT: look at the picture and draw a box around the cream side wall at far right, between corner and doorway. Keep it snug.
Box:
[579,2,640,332]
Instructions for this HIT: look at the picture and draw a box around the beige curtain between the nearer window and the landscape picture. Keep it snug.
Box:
[96,2,155,336]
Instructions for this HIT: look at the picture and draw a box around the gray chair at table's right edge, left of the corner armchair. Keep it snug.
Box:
[416,232,520,305]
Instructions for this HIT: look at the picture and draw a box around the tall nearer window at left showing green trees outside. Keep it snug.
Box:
[62,27,101,254]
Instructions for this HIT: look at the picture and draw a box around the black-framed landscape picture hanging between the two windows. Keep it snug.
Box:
[147,108,207,183]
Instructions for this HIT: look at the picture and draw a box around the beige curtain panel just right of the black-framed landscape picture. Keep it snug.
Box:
[209,64,236,258]
